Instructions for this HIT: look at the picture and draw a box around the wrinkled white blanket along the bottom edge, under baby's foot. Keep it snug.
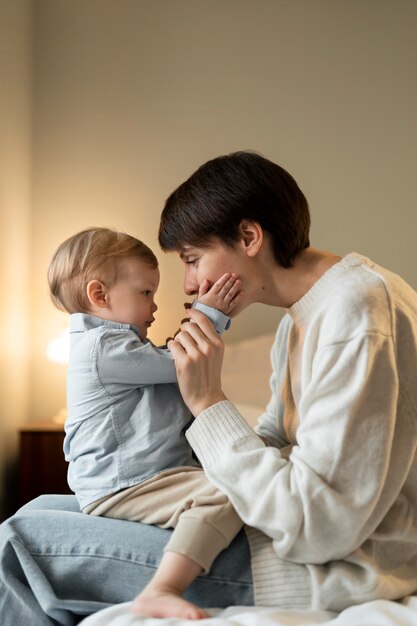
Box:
[81,596,417,626]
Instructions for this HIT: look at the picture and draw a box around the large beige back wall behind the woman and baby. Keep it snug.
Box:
[0,0,417,508]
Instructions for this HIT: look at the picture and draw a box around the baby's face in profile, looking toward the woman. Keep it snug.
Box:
[108,257,159,339]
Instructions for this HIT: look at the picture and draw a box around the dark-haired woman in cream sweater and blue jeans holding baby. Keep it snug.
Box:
[0,152,417,626]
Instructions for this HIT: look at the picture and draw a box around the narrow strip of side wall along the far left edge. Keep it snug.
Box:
[0,0,31,517]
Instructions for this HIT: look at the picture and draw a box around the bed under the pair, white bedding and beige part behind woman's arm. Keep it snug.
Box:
[81,334,417,626]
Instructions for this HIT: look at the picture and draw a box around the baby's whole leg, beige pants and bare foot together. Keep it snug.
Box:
[88,467,242,619]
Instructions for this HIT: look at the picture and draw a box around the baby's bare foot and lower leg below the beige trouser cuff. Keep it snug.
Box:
[132,552,208,620]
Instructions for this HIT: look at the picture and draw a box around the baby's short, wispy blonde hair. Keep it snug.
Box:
[48,228,158,313]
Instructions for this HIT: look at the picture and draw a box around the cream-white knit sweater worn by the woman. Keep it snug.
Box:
[187,254,417,610]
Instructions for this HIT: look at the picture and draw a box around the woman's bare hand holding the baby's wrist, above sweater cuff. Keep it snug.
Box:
[167,309,226,416]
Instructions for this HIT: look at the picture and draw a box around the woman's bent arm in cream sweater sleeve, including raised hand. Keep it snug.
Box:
[168,310,404,563]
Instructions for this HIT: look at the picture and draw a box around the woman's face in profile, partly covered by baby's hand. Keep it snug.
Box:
[179,240,251,317]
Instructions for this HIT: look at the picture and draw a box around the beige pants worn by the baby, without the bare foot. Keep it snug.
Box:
[83,467,243,572]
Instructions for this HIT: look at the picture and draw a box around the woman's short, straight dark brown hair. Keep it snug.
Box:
[159,152,310,267]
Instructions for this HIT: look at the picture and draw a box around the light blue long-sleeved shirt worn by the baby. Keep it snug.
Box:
[64,304,229,509]
